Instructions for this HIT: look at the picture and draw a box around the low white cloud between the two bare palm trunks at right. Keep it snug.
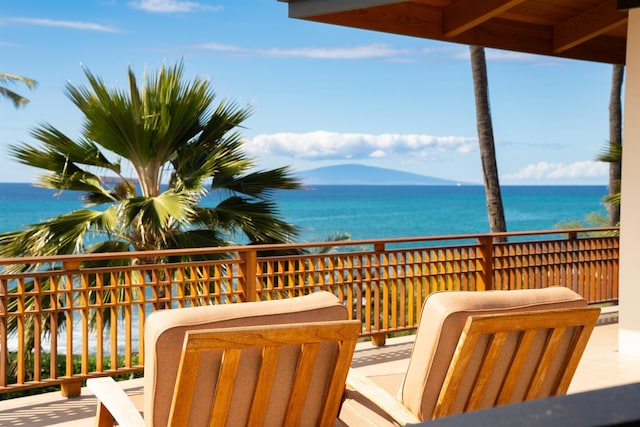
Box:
[505,160,609,180]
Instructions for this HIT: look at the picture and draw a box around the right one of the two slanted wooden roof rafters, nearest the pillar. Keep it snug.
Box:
[553,0,628,53]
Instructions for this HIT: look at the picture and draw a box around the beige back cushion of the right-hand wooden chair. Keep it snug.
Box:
[399,287,587,420]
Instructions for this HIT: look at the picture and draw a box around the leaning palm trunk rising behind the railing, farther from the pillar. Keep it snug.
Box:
[469,46,507,240]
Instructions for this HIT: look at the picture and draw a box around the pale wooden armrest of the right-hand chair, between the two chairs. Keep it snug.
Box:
[347,369,421,425]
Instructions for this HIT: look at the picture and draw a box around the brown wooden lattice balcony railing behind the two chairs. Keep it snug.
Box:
[0,228,618,398]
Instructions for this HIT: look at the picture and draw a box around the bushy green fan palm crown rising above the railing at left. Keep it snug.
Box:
[0,64,300,257]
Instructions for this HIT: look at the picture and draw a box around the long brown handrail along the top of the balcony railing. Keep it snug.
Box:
[0,227,619,265]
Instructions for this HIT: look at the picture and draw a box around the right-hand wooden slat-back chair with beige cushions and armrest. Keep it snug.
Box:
[340,288,600,425]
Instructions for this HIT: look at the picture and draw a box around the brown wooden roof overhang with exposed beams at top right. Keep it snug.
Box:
[281,0,629,64]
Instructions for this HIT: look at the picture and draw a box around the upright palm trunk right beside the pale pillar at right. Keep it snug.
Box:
[609,64,624,226]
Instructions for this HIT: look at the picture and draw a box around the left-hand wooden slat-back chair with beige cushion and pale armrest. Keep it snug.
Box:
[87,292,362,427]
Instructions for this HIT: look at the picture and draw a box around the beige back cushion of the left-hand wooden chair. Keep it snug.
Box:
[144,292,348,426]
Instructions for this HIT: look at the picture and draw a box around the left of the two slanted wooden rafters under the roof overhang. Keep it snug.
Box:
[443,0,524,38]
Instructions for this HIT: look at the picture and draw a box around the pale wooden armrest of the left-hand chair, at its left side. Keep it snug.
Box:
[87,377,145,427]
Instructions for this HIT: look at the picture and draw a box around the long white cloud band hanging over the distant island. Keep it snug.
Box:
[245,131,477,160]
